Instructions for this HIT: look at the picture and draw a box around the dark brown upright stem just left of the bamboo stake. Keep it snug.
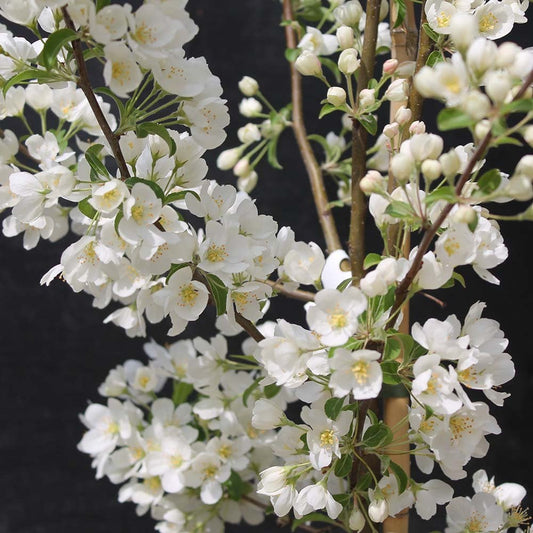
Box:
[349,0,381,284]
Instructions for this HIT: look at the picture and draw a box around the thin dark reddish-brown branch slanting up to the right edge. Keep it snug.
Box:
[386,70,533,328]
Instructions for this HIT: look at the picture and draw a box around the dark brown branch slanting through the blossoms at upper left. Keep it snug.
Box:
[61,6,130,180]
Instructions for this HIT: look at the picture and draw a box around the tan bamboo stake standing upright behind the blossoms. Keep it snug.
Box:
[383,0,418,533]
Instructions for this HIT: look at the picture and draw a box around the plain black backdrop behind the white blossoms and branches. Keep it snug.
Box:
[0,0,533,533]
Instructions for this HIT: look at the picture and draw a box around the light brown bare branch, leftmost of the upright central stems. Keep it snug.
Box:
[283,0,342,253]
